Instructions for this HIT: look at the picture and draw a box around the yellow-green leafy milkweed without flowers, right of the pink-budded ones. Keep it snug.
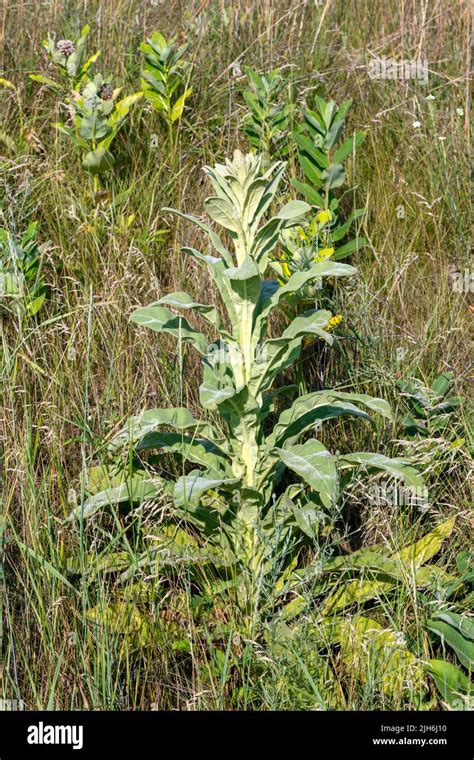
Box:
[140,32,192,140]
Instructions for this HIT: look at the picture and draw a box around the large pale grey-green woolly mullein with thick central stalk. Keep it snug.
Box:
[70,151,422,634]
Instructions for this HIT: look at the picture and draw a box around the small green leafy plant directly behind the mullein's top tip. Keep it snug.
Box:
[243,66,292,158]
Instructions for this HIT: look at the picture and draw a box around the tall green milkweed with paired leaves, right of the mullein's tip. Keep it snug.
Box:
[291,95,367,259]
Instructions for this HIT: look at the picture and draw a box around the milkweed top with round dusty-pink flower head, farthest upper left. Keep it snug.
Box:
[30,25,100,92]
